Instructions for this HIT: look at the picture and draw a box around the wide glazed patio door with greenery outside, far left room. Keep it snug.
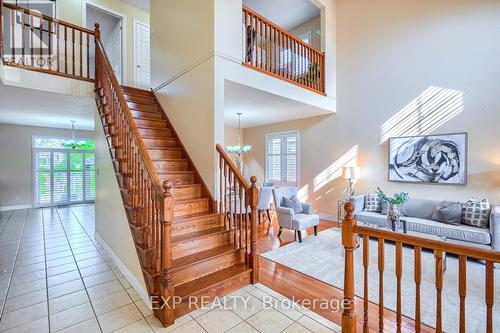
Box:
[33,137,95,207]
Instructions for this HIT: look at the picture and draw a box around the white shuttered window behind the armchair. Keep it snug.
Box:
[266,131,299,186]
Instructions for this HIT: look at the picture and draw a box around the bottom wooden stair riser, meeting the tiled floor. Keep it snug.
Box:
[175,271,251,318]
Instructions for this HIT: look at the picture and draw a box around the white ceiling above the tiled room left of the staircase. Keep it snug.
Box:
[0,83,95,130]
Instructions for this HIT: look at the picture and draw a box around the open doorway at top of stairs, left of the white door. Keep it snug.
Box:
[85,3,126,84]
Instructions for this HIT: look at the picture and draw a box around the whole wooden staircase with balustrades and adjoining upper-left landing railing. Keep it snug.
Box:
[0,0,258,326]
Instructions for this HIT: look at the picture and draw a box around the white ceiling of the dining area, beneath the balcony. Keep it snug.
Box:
[224,81,332,128]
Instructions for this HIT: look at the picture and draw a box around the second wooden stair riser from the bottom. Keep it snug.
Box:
[173,250,245,286]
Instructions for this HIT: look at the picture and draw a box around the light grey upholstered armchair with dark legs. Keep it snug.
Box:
[273,187,319,243]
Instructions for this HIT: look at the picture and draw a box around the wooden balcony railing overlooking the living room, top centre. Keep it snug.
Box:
[243,7,325,94]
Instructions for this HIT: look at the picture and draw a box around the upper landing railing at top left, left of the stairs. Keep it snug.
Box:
[0,0,95,81]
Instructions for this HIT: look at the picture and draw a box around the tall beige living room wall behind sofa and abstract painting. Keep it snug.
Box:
[245,0,500,215]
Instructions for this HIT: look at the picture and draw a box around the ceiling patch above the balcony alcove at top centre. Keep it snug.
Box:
[243,0,321,30]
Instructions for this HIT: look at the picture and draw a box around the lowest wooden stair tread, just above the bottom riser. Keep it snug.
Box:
[175,263,251,298]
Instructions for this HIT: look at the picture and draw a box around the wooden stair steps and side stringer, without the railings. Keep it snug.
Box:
[96,67,255,325]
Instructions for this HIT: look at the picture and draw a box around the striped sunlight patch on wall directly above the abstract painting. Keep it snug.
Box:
[380,86,463,144]
